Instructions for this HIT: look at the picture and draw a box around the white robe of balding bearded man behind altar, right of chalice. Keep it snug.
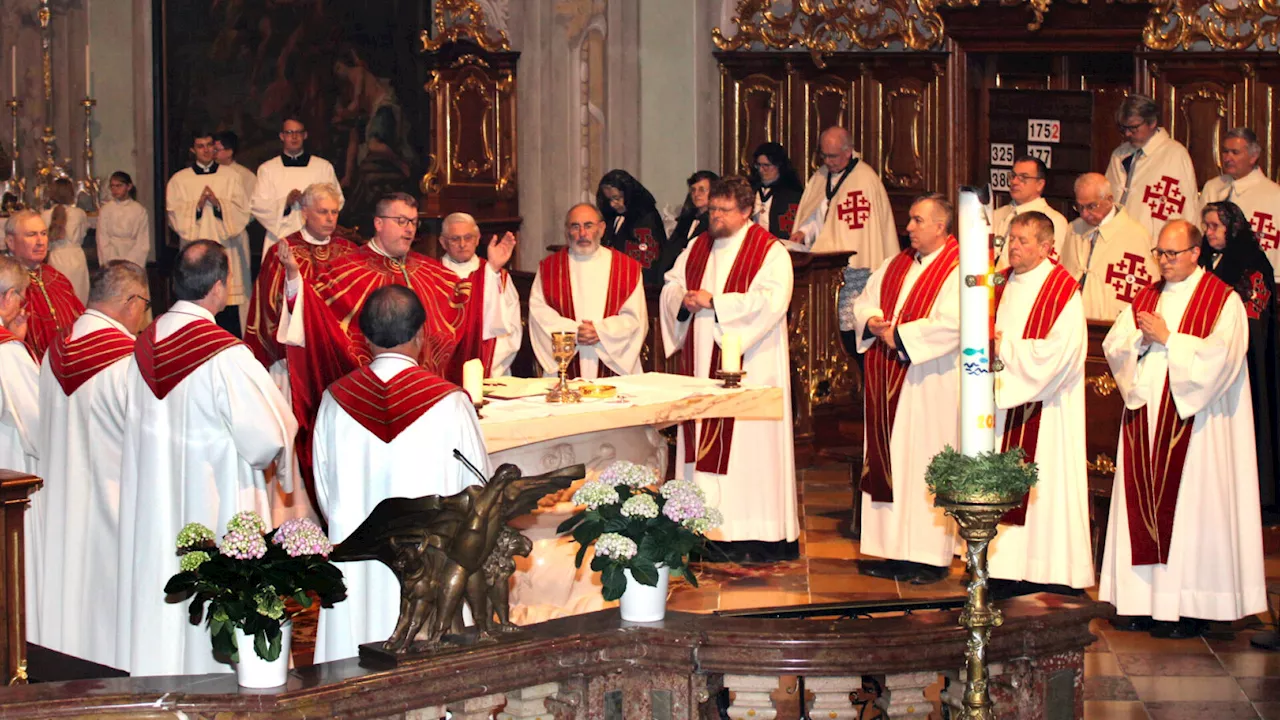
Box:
[529,247,649,380]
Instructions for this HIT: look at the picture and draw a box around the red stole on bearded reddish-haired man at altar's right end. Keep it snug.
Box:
[680,224,778,475]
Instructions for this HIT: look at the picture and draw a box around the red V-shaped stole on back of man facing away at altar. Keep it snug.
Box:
[329,365,462,443]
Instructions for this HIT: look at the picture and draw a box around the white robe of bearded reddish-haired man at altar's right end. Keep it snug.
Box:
[660,223,800,542]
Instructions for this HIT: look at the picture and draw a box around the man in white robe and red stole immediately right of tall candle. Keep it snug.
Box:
[989,210,1093,588]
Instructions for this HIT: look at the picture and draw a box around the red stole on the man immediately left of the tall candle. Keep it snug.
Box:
[861,237,960,502]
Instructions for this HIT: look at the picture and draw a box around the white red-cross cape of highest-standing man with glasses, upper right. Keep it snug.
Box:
[1107,128,1199,240]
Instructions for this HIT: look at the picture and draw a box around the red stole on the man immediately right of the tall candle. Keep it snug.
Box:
[996,260,1080,525]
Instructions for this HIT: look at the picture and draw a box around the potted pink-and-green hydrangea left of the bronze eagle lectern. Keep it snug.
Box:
[164,512,347,688]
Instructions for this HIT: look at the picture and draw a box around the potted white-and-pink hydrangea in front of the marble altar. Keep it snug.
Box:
[558,460,723,623]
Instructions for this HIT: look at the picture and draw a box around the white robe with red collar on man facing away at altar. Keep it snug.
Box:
[315,352,493,662]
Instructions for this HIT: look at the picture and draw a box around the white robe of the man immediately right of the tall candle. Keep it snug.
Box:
[988,260,1093,588]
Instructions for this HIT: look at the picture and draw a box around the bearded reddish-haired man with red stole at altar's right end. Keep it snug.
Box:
[660,177,800,562]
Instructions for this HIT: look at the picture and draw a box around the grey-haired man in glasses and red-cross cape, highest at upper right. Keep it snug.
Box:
[1107,95,1199,237]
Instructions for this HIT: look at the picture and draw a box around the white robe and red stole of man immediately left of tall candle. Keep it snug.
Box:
[854,237,962,566]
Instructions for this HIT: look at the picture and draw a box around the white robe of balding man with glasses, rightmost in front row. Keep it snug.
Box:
[1098,268,1267,620]
